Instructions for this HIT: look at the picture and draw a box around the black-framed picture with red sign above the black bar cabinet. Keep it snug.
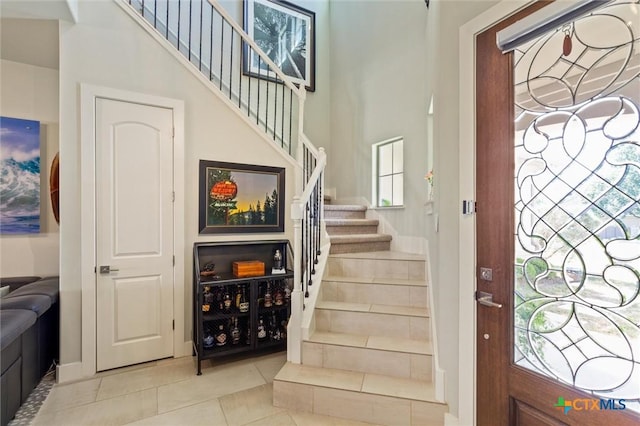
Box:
[198,160,285,234]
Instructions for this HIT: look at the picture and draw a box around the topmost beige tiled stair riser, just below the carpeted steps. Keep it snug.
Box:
[327,256,426,280]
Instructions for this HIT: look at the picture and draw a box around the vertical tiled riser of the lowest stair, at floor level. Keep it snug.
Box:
[273,380,446,426]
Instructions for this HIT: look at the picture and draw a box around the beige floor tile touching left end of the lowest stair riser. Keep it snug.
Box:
[219,383,284,425]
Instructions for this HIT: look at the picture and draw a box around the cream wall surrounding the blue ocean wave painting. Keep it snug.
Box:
[0,60,60,277]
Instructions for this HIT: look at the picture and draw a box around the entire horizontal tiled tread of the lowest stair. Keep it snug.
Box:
[274,362,440,404]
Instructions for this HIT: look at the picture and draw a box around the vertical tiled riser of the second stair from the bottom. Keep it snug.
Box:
[302,342,433,382]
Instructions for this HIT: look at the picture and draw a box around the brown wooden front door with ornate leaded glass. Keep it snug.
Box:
[476,1,640,425]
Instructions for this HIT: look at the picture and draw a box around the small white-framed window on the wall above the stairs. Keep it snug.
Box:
[372,138,404,207]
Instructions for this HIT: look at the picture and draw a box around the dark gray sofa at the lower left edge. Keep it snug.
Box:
[0,277,60,426]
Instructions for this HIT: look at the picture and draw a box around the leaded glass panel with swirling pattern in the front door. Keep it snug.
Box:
[513,1,640,411]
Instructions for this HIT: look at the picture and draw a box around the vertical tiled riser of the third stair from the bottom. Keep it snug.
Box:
[315,308,431,340]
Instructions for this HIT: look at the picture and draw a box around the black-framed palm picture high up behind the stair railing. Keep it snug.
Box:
[242,0,316,92]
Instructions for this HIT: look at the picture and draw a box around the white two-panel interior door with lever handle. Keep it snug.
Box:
[95,98,174,371]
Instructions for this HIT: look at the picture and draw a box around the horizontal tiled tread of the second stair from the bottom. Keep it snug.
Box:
[308,330,433,355]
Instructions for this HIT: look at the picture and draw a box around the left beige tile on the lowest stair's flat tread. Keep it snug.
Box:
[276,363,364,390]
